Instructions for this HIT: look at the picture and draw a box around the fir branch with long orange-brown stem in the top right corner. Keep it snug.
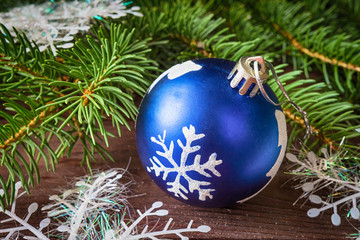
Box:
[248,1,360,100]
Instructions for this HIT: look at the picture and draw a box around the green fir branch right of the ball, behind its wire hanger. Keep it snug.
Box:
[268,65,360,151]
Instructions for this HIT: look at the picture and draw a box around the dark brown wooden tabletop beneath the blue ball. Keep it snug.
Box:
[0,122,355,239]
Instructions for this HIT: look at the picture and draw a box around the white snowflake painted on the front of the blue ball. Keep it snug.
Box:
[147,125,223,201]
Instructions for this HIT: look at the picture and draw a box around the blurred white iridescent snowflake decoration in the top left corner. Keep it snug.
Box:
[0,0,142,55]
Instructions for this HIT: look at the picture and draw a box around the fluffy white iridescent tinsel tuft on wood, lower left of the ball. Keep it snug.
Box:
[42,169,132,239]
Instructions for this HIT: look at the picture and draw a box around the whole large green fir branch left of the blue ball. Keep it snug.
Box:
[0,25,157,208]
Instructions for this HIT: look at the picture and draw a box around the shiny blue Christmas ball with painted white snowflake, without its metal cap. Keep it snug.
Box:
[136,58,287,207]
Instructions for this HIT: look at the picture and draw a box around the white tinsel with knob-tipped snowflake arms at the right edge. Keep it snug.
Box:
[286,145,360,240]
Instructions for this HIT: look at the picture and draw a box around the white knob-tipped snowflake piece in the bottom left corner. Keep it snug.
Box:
[0,182,50,240]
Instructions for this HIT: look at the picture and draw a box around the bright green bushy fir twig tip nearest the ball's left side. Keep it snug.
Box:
[38,23,154,137]
